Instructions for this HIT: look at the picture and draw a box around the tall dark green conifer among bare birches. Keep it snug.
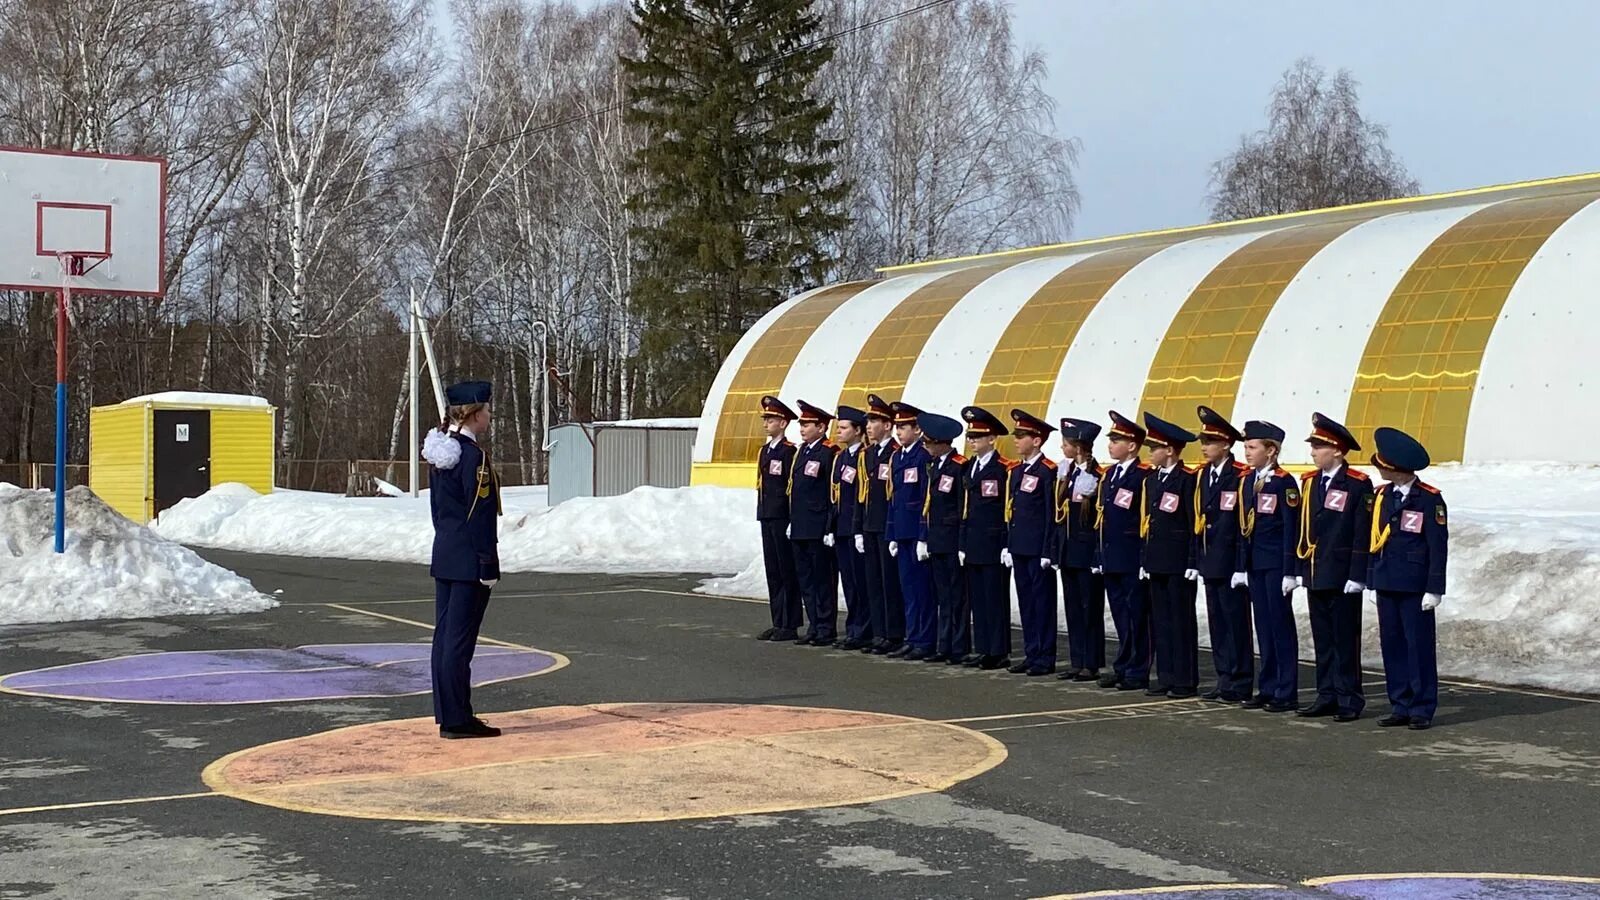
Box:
[622,0,848,412]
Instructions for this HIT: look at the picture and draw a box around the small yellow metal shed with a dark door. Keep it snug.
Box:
[90,391,277,522]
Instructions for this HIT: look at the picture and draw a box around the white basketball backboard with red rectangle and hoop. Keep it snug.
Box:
[0,147,166,296]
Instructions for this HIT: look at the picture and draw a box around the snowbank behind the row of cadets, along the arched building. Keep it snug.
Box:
[698,463,1600,695]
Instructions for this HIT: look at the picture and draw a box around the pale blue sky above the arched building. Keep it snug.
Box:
[434,0,1600,237]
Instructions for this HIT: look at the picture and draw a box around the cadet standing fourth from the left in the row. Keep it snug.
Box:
[856,394,906,655]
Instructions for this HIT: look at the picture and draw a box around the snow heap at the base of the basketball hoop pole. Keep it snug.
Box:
[0,484,277,625]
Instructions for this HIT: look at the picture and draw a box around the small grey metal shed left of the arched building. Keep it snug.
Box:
[550,418,699,506]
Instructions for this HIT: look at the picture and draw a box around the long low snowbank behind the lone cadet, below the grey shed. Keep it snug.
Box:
[155,485,762,573]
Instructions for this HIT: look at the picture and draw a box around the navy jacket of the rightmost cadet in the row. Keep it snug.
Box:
[1366,480,1450,596]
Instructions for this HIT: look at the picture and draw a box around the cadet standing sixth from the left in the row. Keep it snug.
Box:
[917,413,973,665]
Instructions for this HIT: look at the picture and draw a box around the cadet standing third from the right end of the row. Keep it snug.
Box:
[1229,420,1301,713]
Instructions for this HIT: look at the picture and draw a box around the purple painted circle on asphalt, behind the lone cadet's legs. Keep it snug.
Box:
[0,644,565,703]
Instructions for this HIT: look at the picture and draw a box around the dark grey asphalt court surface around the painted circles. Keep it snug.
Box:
[0,551,1600,900]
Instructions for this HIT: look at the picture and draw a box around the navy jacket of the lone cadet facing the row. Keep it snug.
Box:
[427,432,501,581]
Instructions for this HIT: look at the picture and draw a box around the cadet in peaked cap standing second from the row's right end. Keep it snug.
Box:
[1294,413,1373,722]
